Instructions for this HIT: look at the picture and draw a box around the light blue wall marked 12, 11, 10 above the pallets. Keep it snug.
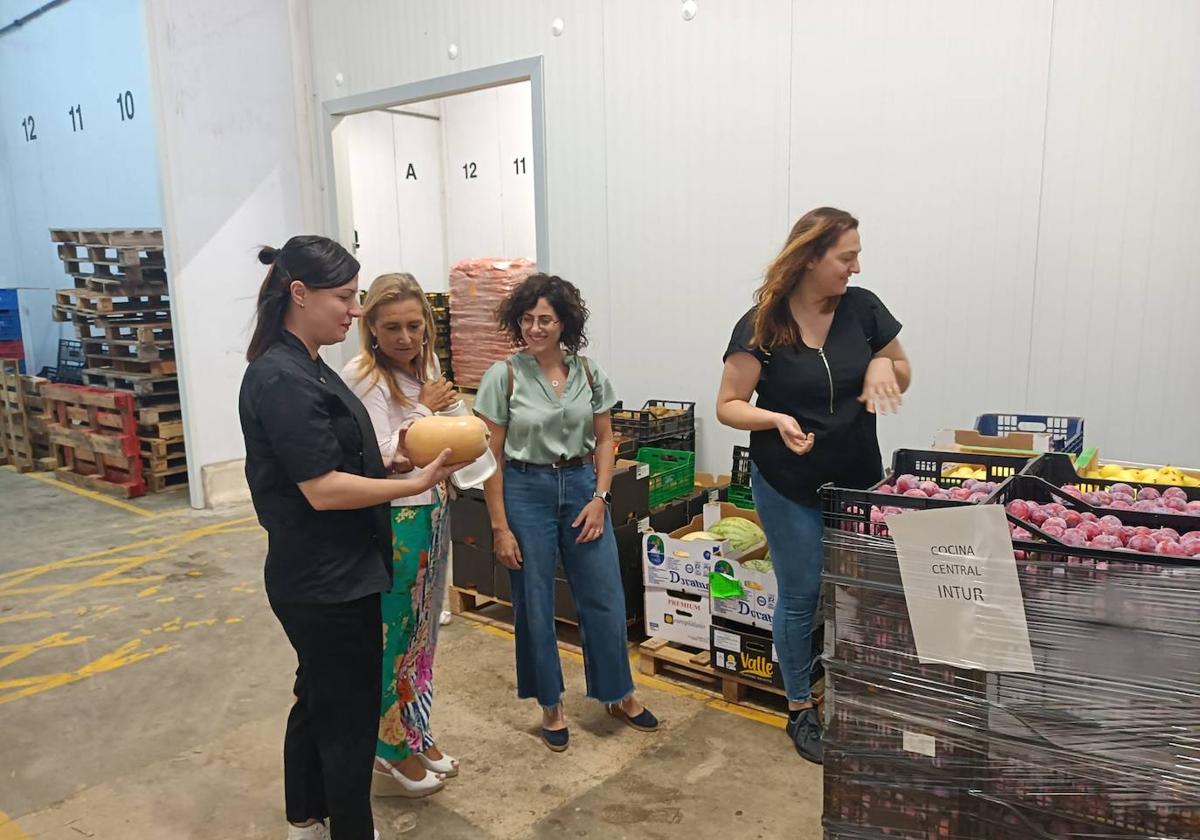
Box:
[0,0,162,366]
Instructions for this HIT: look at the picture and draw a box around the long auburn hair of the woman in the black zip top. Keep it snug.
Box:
[754,208,858,350]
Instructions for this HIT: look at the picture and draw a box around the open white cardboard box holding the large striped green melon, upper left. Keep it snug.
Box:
[642,502,767,595]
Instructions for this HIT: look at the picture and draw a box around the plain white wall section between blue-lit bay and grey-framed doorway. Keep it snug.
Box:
[146,0,316,506]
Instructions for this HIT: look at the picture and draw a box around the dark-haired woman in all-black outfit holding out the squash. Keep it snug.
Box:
[239,236,455,840]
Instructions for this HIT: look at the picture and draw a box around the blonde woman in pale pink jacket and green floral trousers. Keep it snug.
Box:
[342,274,458,798]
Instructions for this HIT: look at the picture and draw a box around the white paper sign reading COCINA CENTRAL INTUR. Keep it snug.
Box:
[888,505,1033,673]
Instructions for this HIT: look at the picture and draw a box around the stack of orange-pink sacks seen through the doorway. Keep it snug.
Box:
[450,258,538,388]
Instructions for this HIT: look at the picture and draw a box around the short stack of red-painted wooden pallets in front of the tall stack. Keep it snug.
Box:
[42,384,146,498]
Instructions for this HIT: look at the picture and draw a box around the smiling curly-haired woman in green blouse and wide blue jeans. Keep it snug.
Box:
[475,274,659,752]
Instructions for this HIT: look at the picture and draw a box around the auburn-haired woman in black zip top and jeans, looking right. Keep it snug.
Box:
[716,208,912,763]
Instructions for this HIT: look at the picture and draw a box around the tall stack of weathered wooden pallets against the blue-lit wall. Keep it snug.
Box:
[50,229,187,493]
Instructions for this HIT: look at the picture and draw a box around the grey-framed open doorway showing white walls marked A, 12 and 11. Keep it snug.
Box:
[316,59,548,374]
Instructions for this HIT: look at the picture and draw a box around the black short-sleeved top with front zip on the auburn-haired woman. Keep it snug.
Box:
[725,287,900,506]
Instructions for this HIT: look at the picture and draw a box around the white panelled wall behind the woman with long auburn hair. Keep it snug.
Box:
[310,0,1200,469]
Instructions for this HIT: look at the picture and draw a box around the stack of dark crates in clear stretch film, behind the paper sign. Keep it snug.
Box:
[823,488,1200,840]
